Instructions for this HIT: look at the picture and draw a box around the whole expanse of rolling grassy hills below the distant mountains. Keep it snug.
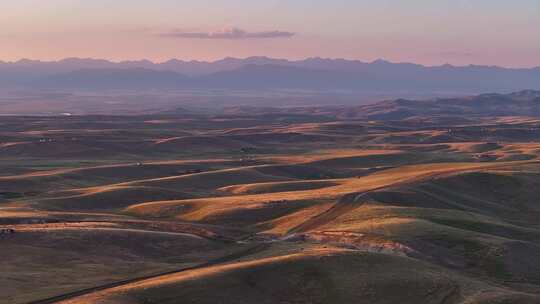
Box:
[0,98,540,304]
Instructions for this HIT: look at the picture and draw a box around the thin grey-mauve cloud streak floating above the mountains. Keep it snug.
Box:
[160,28,295,40]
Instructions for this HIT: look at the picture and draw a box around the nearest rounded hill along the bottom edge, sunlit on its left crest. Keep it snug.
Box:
[57,249,538,304]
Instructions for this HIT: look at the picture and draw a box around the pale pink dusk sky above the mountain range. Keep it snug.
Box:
[0,0,540,67]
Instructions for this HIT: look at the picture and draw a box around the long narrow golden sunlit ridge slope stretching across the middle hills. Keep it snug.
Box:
[127,163,524,221]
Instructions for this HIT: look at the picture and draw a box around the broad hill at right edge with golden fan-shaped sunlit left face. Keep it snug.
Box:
[265,167,540,285]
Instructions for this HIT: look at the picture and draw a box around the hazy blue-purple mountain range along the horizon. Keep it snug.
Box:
[0,57,540,94]
